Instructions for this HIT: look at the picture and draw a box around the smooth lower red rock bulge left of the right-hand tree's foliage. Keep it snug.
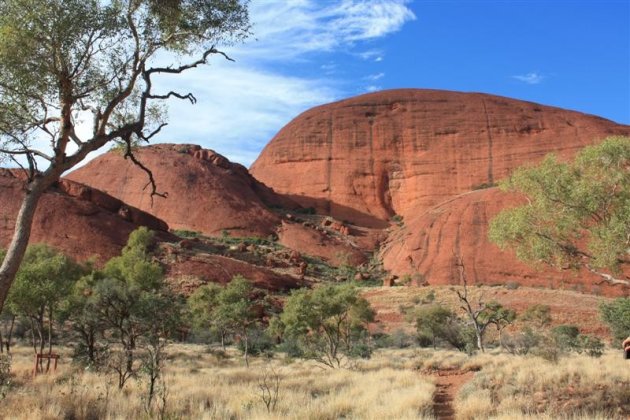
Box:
[381,188,630,296]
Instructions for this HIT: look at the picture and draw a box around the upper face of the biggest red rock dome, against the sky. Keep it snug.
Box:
[250,89,630,227]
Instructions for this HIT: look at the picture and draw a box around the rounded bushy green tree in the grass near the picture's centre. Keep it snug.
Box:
[273,285,374,368]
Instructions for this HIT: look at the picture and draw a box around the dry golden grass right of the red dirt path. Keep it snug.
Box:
[455,351,630,419]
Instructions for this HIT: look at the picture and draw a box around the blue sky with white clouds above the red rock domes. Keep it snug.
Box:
[155,0,630,166]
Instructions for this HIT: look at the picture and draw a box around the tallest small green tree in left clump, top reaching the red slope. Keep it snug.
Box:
[85,227,181,388]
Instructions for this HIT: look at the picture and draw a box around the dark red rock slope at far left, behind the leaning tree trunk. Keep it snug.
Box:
[0,169,173,264]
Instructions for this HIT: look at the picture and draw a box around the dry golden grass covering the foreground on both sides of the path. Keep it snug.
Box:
[0,344,630,420]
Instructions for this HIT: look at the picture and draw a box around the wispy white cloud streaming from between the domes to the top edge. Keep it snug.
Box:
[147,0,415,165]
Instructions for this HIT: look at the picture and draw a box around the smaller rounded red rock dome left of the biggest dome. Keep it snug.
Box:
[67,144,295,236]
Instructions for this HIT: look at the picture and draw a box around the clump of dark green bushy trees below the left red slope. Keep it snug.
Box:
[65,227,183,388]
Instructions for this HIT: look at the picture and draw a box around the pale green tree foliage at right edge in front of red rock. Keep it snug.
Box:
[489,137,630,273]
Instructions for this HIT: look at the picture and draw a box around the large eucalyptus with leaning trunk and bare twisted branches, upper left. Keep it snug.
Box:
[0,0,249,309]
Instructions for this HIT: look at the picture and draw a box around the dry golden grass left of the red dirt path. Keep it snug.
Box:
[0,345,435,420]
